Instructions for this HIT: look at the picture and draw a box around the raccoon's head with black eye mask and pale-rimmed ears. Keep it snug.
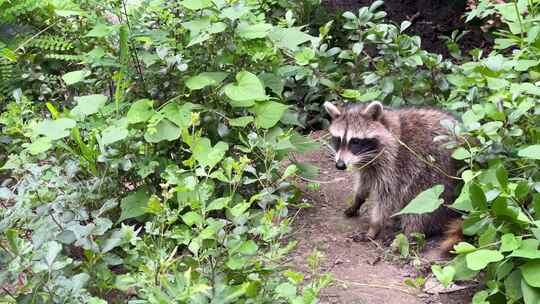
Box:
[324,101,392,170]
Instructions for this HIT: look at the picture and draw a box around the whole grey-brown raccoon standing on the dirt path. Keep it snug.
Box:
[324,101,461,251]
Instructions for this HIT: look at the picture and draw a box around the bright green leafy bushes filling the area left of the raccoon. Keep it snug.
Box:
[0,0,330,303]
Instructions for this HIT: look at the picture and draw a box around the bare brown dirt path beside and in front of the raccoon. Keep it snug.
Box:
[289,132,473,304]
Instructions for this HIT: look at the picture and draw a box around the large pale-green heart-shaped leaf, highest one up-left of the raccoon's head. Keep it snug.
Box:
[224,71,268,107]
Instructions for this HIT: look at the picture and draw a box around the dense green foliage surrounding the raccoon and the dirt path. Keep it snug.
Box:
[0,0,540,304]
